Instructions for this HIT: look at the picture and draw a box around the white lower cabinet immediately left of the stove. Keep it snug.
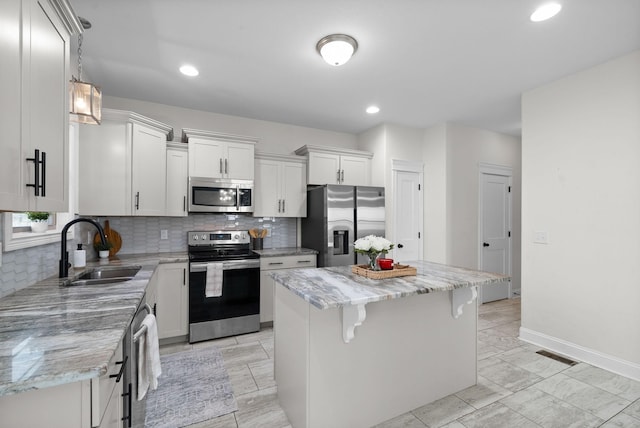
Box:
[154,263,189,339]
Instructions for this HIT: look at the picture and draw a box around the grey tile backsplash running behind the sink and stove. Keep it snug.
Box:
[0,214,297,297]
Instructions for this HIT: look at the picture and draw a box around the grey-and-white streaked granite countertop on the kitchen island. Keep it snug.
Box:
[270,261,511,309]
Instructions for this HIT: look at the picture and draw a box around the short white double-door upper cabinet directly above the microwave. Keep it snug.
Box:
[182,129,257,180]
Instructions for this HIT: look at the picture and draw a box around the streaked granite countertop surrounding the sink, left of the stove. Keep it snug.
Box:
[0,252,188,395]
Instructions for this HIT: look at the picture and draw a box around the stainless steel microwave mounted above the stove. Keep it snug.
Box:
[189,177,253,213]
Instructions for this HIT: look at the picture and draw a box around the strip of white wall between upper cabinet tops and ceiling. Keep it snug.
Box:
[103,96,357,154]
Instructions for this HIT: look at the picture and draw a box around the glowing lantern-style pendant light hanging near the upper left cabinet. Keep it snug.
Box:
[69,17,102,125]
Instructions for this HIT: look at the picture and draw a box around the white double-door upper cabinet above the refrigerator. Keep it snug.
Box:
[296,145,373,186]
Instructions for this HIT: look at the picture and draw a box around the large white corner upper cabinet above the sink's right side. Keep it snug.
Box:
[78,109,173,216]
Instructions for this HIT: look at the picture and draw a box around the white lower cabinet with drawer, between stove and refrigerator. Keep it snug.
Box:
[260,254,316,322]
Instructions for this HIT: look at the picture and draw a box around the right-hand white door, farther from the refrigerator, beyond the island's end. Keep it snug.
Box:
[480,173,511,303]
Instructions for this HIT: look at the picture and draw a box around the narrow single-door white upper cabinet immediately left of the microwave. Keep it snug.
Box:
[167,143,189,217]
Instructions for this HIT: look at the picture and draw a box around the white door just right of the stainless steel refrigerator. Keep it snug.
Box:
[392,162,423,262]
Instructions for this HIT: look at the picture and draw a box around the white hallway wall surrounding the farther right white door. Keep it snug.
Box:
[422,123,521,274]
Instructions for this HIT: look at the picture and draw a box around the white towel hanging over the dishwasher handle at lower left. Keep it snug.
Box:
[138,314,162,401]
